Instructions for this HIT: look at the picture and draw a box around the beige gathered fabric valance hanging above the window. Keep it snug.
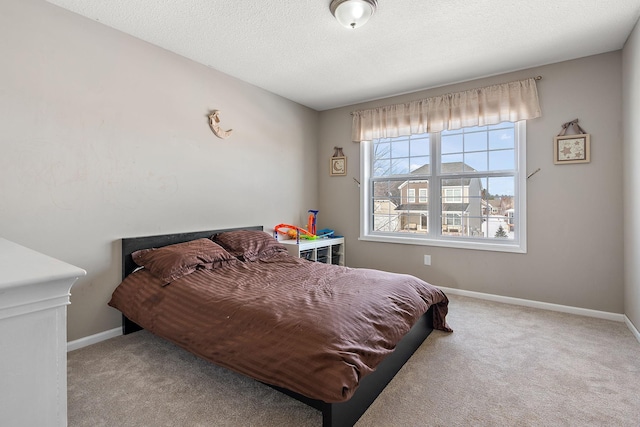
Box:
[352,78,541,142]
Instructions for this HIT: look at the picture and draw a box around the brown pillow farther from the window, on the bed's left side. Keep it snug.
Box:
[131,238,237,282]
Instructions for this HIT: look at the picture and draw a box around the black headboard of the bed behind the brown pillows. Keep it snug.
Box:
[122,225,263,279]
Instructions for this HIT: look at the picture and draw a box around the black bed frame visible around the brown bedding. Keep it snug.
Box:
[122,226,433,427]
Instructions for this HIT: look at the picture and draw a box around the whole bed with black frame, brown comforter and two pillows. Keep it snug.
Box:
[109,226,451,427]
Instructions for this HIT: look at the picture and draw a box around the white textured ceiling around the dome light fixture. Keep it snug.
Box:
[47,0,640,111]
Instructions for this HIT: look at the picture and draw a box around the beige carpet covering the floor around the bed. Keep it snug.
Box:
[68,296,640,427]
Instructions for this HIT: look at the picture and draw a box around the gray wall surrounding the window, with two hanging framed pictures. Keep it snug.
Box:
[318,51,624,313]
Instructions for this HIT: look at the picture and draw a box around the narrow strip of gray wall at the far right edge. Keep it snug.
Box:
[622,22,640,329]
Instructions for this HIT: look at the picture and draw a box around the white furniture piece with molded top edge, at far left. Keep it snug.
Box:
[0,238,86,427]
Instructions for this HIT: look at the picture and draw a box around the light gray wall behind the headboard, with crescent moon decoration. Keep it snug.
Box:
[0,0,318,340]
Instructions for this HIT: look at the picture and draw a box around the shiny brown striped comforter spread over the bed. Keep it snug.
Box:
[109,253,450,402]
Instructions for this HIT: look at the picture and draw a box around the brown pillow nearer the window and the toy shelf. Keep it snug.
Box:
[212,230,287,261]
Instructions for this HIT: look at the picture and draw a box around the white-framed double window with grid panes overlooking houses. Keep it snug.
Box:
[361,121,526,252]
